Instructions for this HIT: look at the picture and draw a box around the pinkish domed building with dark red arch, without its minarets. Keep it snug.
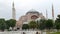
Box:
[16,10,44,28]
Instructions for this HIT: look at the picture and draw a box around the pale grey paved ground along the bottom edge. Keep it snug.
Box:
[0,31,46,34]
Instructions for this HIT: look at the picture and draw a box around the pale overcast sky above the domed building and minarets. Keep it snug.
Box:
[0,0,60,20]
